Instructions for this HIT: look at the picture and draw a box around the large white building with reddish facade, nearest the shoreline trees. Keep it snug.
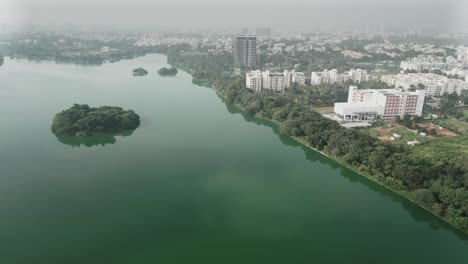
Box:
[334,86,425,122]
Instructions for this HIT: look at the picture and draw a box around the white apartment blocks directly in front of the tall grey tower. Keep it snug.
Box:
[245,70,305,92]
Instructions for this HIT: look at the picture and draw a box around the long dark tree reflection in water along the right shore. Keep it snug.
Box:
[220,97,468,240]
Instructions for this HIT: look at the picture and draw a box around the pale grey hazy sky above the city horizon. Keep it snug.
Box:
[0,0,468,30]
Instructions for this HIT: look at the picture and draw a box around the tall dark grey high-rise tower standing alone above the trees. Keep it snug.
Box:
[233,35,257,68]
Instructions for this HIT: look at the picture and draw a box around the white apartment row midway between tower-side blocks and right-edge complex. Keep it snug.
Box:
[310,69,370,85]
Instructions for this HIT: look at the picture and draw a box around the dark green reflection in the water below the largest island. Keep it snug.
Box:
[56,130,134,148]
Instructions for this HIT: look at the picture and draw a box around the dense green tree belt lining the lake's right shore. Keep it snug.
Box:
[169,53,468,232]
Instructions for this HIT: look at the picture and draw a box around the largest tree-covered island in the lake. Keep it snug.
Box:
[52,104,140,137]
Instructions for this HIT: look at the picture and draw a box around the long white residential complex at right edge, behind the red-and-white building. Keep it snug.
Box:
[382,73,468,96]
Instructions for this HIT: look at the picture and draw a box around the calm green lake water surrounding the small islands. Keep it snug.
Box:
[0,55,468,264]
